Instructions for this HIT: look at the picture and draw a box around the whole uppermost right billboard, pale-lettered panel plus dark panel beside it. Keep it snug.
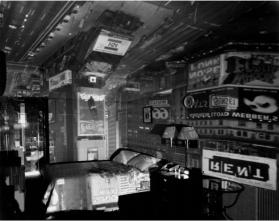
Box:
[188,51,279,90]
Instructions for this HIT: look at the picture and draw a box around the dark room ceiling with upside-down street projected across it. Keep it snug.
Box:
[0,1,279,94]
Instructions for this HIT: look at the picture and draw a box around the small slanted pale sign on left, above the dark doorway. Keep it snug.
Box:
[49,70,72,91]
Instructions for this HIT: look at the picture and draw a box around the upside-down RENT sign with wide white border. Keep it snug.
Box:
[202,150,277,190]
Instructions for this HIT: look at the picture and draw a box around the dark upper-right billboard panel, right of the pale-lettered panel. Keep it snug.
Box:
[219,52,279,86]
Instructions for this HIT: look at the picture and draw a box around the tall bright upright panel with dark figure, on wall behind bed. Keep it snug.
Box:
[77,93,104,136]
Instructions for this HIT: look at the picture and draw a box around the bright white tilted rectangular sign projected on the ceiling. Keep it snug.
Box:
[93,30,132,56]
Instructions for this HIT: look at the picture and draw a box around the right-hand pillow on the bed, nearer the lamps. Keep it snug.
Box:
[127,154,160,172]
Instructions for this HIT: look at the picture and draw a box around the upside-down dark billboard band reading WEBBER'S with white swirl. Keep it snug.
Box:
[184,85,279,122]
